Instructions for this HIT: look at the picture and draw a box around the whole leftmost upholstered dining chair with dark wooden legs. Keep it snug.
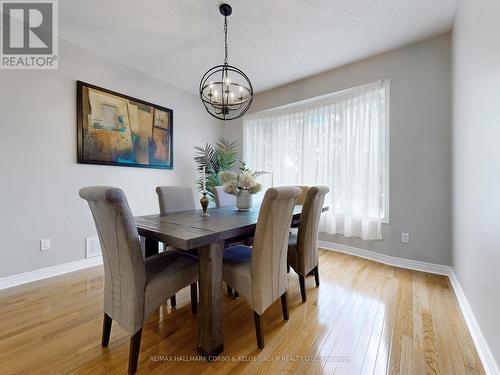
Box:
[80,186,198,374]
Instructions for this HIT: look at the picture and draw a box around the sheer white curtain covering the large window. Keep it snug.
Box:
[243,81,389,240]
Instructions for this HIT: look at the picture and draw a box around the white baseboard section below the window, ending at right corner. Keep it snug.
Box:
[318,241,451,276]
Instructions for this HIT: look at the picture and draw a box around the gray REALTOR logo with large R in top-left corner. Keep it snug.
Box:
[0,0,58,69]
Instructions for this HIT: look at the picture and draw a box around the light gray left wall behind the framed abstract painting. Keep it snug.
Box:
[0,41,221,277]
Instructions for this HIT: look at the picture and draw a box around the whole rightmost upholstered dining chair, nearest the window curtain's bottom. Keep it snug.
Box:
[288,186,330,302]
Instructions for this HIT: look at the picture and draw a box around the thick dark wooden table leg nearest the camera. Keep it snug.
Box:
[198,241,224,360]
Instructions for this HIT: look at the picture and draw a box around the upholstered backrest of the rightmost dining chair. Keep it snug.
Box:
[297,186,330,276]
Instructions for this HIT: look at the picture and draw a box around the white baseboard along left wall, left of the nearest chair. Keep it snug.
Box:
[0,256,102,290]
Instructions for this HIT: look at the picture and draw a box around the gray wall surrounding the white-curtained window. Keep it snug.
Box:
[224,34,451,265]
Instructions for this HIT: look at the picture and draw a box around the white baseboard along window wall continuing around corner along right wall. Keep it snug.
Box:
[317,241,500,375]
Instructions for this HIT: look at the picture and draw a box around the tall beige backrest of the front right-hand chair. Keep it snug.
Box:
[252,186,300,314]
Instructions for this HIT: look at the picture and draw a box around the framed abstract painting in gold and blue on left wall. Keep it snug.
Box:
[77,81,173,169]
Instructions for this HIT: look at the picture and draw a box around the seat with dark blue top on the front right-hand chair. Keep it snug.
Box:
[222,245,252,306]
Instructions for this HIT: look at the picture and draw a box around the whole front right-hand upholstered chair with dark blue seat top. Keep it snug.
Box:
[222,187,300,349]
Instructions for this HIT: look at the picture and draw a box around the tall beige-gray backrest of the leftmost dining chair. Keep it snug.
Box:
[80,186,146,334]
